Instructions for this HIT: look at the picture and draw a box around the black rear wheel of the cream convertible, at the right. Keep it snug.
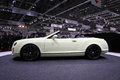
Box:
[85,44,101,60]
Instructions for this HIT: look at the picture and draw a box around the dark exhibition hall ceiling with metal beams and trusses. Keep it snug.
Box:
[0,0,120,27]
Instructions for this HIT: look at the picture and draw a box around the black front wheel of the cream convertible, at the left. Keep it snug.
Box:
[20,44,40,61]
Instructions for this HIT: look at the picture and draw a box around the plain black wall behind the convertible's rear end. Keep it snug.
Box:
[85,33,120,52]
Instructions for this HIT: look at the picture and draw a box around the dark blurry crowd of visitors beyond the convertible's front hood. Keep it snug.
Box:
[0,32,45,52]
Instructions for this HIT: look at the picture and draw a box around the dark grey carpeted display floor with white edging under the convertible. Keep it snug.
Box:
[0,52,120,80]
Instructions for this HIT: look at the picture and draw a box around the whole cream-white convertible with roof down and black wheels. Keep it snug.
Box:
[12,31,108,61]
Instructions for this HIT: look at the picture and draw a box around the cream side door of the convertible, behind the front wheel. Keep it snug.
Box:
[45,38,77,53]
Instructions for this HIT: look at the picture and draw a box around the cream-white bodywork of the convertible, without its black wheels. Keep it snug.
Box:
[12,31,108,57]
